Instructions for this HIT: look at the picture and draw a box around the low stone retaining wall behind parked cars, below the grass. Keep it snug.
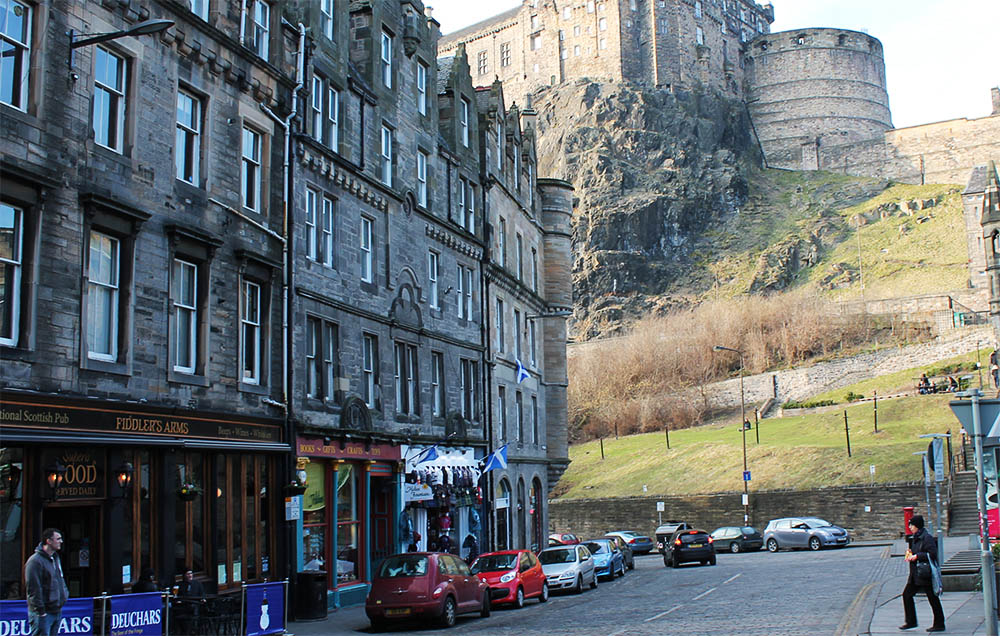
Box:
[549,482,928,541]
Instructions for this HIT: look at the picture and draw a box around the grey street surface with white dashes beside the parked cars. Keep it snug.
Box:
[291,547,886,636]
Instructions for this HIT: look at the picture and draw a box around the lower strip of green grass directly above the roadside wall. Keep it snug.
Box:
[558,395,959,499]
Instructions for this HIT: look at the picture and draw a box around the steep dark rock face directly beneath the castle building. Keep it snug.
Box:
[535,80,756,338]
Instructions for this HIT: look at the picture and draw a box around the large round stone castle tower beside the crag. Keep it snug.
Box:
[746,29,892,170]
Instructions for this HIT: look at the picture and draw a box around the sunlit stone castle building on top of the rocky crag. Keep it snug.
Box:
[440,0,774,101]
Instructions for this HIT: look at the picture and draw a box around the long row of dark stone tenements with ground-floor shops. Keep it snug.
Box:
[0,0,572,605]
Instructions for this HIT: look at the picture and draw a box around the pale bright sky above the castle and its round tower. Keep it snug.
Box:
[424,0,1000,128]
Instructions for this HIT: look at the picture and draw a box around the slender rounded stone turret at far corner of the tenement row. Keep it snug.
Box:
[538,179,573,492]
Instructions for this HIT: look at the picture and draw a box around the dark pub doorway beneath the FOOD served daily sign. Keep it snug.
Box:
[42,504,103,597]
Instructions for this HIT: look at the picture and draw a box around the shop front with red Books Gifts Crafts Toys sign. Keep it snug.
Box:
[296,436,401,607]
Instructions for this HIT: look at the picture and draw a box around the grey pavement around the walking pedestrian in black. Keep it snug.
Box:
[864,536,986,636]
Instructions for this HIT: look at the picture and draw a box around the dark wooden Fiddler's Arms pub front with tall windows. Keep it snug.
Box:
[0,391,291,598]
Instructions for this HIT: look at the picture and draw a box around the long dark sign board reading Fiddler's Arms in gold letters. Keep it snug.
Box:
[0,395,284,443]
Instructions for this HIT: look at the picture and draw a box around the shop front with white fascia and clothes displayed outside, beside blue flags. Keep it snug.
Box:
[399,446,484,562]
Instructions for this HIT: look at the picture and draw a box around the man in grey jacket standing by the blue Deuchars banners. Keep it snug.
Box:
[24,528,69,636]
